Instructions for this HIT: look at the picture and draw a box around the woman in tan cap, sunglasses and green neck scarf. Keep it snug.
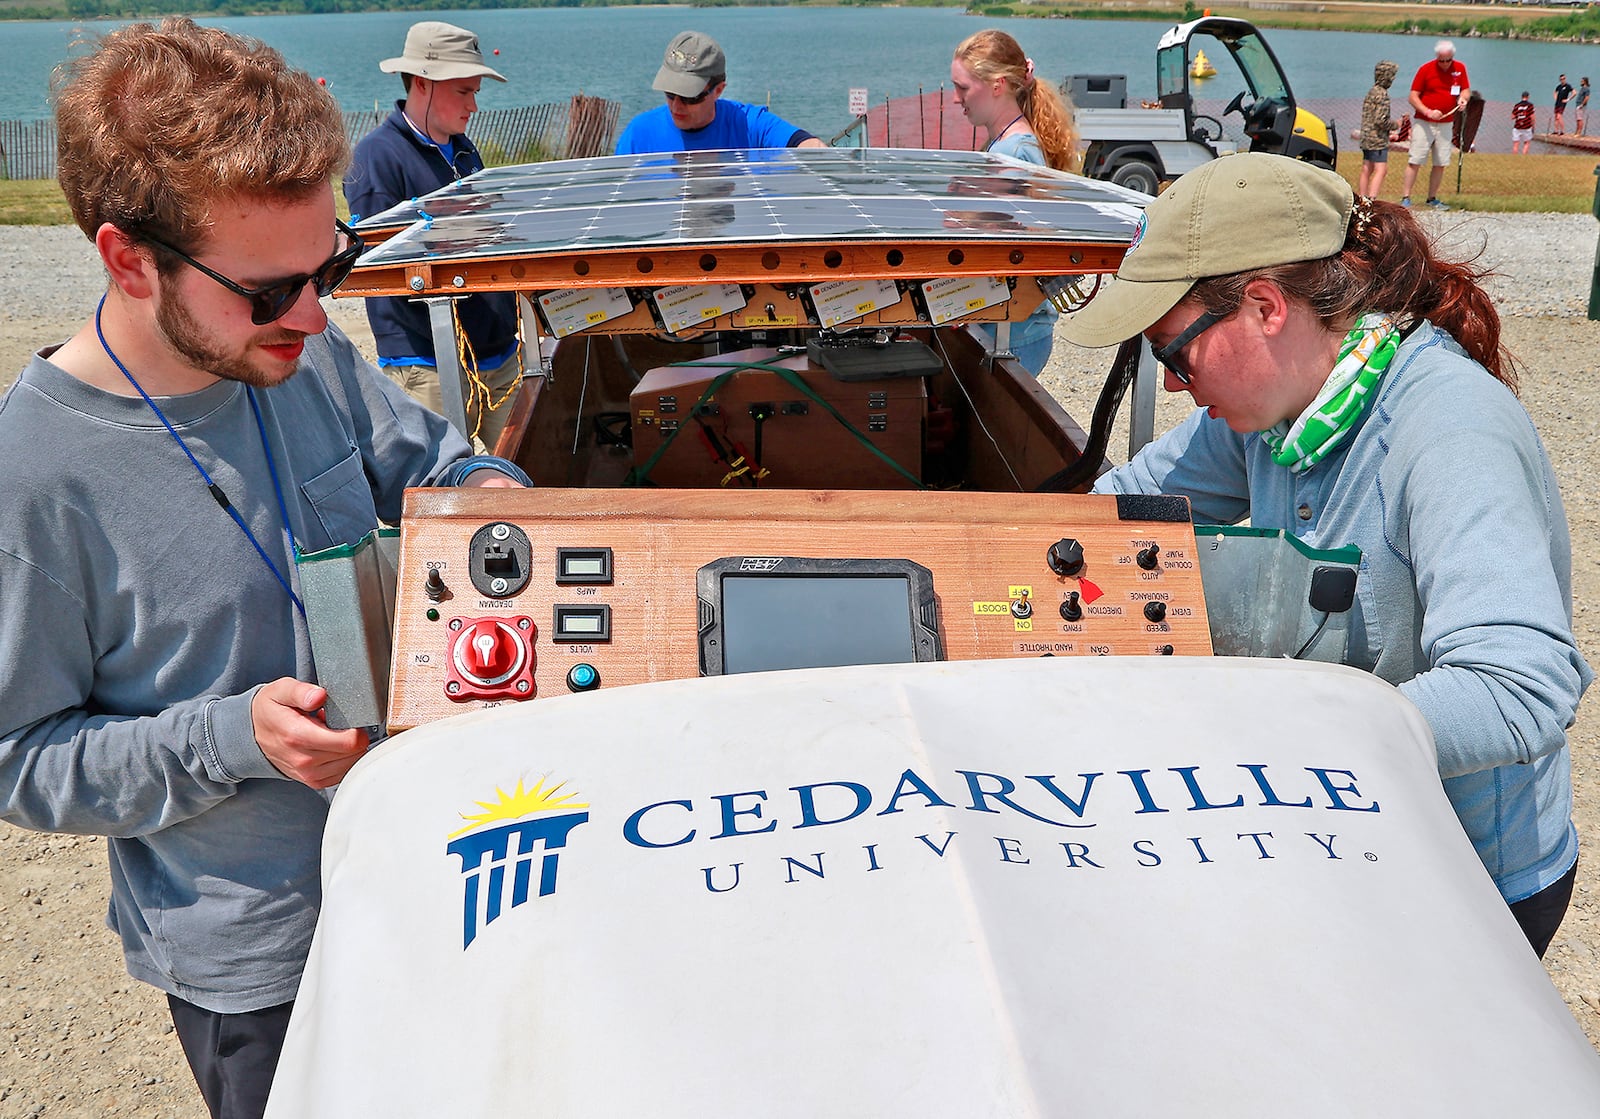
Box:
[1062,154,1594,954]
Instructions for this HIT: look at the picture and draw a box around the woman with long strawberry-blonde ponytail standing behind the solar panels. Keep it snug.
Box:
[950,30,1082,376]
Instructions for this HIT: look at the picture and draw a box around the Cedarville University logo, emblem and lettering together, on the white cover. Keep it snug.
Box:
[445,762,1381,948]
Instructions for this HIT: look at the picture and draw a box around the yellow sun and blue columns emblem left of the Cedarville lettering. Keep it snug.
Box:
[445,778,589,949]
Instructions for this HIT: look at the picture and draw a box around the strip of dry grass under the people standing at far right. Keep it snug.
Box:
[1339,152,1595,213]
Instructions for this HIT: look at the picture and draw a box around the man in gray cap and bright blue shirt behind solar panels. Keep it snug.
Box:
[616,30,826,155]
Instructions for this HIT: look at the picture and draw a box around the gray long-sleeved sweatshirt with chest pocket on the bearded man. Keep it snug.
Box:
[0,327,515,1013]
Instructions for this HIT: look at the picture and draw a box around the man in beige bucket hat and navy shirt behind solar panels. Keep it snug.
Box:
[344,21,522,450]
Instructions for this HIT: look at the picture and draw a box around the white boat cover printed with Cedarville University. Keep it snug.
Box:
[269,658,1600,1119]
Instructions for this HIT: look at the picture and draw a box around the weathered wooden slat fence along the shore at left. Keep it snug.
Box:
[0,93,622,179]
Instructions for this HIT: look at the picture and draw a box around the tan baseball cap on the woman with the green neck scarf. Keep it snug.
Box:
[1061,152,1355,347]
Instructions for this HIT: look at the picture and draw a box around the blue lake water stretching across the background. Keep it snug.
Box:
[0,8,1600,128]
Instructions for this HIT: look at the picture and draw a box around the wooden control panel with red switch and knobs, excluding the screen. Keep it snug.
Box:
[389,488,1211,730]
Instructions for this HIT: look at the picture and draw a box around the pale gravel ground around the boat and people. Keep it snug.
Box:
[0,213,1600,1119]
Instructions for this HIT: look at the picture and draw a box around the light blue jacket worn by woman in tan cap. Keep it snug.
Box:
[1094,322,1594,901]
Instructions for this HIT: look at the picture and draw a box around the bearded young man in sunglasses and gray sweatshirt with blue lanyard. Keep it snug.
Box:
[0,19,526,1119]
